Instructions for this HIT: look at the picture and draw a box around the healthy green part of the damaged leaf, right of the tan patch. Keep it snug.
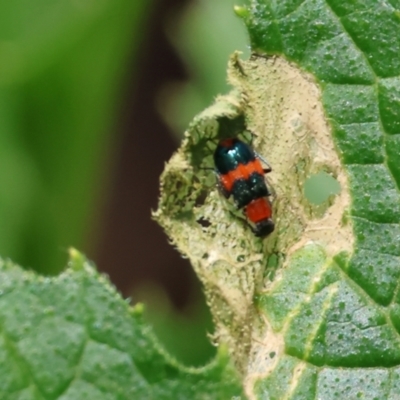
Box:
[238,0,400,399]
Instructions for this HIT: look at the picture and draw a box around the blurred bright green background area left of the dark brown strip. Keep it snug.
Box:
[0,0,146,273]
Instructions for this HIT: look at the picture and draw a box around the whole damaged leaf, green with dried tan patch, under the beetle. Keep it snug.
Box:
[155,0,400,400]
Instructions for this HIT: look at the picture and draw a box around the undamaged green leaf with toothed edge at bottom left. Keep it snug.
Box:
[0,250,240,400]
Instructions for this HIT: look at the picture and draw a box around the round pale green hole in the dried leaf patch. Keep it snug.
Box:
[304,172,340,205]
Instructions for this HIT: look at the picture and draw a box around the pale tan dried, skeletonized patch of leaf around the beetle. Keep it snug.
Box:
[155,54,354,398]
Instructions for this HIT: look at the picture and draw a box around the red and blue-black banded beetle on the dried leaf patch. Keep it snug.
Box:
[214,138,275,237]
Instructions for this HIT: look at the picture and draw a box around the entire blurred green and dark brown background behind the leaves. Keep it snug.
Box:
[0,0,249,365]
